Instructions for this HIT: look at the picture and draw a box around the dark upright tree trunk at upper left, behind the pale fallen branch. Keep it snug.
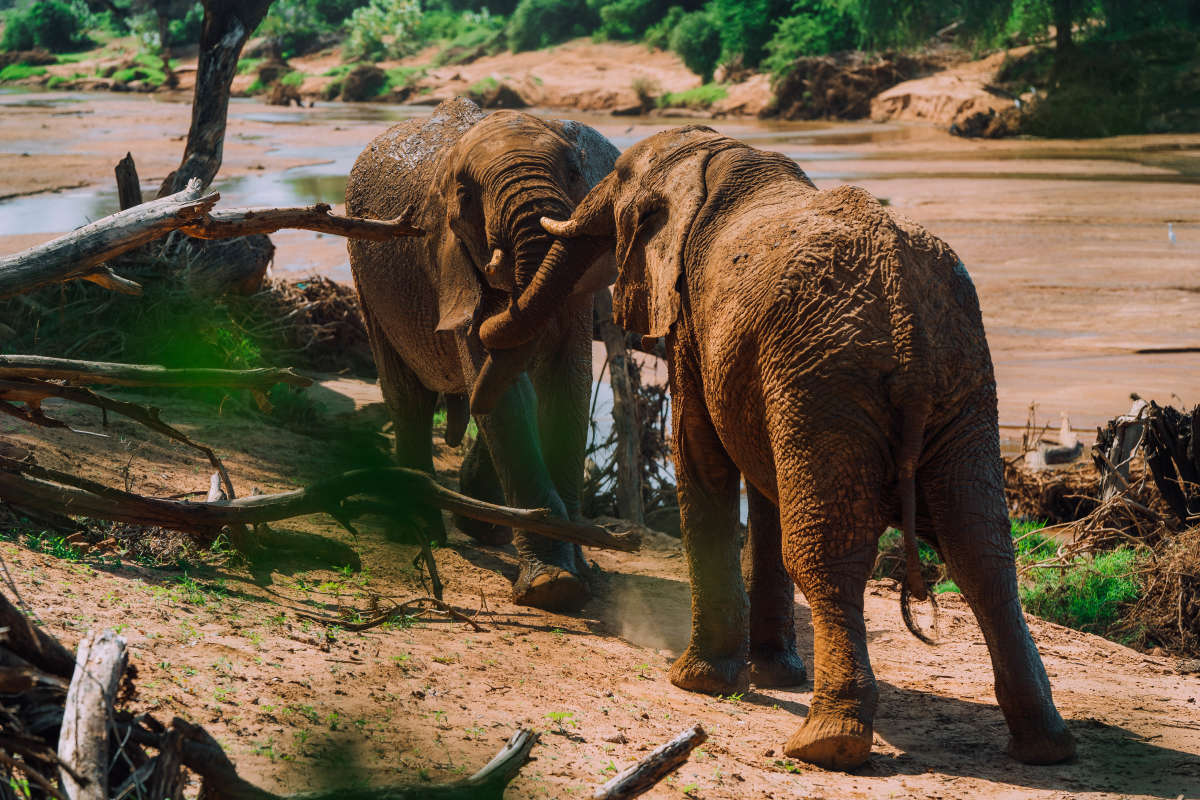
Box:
[158,0,271,197]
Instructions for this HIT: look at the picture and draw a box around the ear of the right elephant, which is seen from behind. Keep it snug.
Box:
[612,149,710,338]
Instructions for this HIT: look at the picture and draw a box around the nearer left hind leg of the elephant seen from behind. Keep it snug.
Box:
[776,434,886,769]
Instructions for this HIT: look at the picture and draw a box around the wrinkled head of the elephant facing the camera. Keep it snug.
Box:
[430,112,611,414]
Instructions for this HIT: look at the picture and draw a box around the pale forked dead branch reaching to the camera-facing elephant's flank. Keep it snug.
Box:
[0,180,422,297]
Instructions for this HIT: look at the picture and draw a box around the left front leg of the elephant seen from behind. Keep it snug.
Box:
[671,352,749,694]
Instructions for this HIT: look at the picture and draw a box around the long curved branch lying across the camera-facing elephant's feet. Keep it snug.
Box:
[0,456,640,552]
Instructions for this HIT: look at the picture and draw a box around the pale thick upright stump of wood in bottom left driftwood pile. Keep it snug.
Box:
[59,631,127,800]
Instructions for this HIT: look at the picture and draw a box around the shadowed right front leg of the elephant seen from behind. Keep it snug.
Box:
[742,481,808,687]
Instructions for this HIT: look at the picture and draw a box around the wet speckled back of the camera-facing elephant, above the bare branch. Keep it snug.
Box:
[346,97,485,224]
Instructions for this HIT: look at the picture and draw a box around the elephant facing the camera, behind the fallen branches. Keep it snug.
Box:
[346,98,618,610]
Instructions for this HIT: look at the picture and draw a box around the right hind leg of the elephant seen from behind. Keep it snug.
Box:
[918,431,1075,764]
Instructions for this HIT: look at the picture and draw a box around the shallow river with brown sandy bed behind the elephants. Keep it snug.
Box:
[0,94,1200,435]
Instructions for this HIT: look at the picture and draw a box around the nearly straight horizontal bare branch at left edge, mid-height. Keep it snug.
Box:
[0,355,312,391]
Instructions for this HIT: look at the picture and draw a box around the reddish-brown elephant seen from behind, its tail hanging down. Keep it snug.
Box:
[480,126,1074,769]
